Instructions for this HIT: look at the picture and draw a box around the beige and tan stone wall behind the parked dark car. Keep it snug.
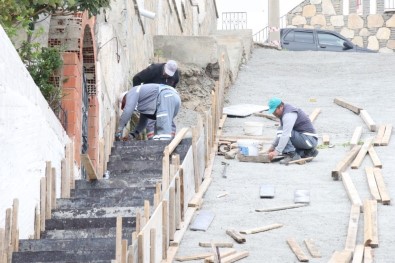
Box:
[287,0,395,53]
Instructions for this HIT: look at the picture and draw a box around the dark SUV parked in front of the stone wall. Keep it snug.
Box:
[280,28,376,53]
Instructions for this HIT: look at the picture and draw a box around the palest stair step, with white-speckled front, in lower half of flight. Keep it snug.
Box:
[52,207,142,219]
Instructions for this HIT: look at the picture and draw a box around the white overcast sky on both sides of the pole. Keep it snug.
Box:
[216,0,304,34]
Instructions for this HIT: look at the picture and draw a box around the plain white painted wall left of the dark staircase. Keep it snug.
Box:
[0,26,69,238]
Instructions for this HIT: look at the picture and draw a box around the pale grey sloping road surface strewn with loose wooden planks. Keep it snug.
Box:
[177,48,395,263]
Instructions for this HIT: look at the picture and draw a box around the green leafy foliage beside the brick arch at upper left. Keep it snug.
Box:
[0,0,110,112]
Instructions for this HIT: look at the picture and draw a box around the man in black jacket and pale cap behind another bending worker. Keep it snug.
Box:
[133,60,180,139]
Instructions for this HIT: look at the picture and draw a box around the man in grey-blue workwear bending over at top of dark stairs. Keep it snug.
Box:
[115,84,181,141]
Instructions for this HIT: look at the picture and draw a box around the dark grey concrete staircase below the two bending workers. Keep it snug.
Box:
[12,139,192,263]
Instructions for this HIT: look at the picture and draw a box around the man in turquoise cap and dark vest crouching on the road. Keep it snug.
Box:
[268,98,318,164]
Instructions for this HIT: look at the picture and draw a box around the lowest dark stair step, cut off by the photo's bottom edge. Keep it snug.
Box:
[12,249,115,263]
